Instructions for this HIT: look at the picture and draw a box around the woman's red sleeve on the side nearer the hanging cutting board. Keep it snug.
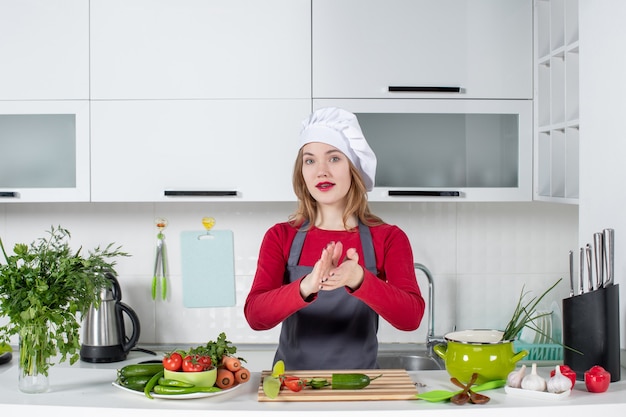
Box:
[244,223,308,330]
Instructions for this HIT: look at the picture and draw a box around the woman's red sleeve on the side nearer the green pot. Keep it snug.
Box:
[352,225,425,331]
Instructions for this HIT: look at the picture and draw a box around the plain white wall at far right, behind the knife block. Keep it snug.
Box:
[579,0,626,349]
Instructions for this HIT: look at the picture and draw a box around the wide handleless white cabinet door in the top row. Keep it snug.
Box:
[91,0,311,99]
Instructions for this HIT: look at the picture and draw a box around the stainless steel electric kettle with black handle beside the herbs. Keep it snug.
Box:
[80,272,141,363]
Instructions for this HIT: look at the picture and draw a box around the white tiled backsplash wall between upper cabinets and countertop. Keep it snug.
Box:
[0,202,578,346]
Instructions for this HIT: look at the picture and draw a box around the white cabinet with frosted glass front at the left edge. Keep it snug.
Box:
[0,100,90,203]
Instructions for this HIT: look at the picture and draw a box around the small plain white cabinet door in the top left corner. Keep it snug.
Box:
[0,0,89,100]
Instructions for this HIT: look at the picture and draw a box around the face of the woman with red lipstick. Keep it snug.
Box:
[302,142,352,204]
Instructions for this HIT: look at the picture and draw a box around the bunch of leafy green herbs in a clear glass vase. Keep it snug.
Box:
[0,226,129,392]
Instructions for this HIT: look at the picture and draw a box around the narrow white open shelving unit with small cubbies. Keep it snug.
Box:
[534,0,580,204]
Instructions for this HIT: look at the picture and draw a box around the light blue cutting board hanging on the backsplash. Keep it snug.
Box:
[180,230,235,308]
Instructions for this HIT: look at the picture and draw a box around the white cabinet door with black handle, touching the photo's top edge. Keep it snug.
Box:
[313,0,533,99]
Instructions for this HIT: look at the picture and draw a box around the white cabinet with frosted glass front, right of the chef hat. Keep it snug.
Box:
[313,99,532,202]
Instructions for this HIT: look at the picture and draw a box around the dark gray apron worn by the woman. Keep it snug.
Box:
[274,222,378,369]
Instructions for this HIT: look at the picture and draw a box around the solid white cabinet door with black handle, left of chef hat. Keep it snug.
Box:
[91,100,311,202]
